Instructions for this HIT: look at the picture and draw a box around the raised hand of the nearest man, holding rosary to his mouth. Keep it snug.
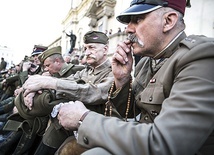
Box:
[112,40,133,88]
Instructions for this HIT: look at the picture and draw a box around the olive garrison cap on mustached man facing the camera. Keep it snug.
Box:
[83,31,109,44]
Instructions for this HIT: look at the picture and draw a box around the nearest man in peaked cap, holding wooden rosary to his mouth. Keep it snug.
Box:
[58,0,214,155]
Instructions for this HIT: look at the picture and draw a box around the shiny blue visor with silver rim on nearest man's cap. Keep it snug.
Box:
[116,4,162,24]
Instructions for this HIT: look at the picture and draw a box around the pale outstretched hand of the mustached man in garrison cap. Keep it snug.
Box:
[22,75,57,96]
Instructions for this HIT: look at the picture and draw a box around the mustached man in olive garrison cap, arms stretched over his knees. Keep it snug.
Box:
[23,31,113,155]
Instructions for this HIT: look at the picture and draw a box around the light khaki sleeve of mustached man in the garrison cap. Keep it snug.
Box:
[57,72,114,105]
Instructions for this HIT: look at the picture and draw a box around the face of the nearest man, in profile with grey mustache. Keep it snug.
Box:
[126,11,163,57]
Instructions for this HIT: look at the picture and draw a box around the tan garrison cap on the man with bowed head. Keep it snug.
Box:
[38,46,62,63]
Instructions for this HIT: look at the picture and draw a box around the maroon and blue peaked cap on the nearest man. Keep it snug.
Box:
[116,0,191,24]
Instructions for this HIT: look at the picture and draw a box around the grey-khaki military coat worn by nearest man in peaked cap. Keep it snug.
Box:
[78,33,214,155]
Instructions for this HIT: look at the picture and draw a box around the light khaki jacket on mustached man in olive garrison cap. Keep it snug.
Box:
[56,60,113,105]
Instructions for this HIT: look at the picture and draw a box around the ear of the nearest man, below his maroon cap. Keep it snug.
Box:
[163,12,179,33]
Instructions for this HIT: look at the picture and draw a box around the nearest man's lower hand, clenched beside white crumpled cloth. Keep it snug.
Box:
[57,101,89,130]
